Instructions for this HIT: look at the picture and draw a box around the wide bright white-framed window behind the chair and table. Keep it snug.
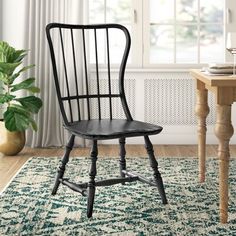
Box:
[88,0,232,68]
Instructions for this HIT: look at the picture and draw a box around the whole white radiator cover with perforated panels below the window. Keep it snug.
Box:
[91,72,236,144]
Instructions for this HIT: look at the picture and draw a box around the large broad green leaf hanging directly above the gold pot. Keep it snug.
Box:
[3,106,31,131]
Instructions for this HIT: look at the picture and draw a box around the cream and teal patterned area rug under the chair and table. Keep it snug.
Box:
[0,158,236,236]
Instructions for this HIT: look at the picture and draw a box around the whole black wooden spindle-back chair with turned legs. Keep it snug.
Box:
[46,23,167,217]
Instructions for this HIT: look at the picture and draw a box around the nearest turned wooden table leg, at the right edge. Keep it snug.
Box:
[215,105,234,223]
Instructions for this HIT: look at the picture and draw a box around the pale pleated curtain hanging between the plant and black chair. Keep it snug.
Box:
[20,0,84,147]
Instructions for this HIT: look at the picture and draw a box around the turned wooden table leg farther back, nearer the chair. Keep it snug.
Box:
[195,89,209,182]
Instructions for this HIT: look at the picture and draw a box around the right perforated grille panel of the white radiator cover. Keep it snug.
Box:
[144,73,215,125]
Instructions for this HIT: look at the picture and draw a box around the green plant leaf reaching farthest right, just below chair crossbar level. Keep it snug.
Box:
[15,96,43,113]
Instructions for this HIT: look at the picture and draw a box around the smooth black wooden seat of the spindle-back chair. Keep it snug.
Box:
[65,119,162,140]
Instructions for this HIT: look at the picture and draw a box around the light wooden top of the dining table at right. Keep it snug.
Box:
[190,69,236,87]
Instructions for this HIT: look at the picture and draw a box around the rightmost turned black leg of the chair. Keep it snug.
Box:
[144,136,167,204]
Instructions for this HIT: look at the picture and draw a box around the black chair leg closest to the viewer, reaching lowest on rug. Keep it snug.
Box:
[87,140,98,218]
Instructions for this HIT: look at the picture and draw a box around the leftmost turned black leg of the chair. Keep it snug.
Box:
[52,135,75,195]
